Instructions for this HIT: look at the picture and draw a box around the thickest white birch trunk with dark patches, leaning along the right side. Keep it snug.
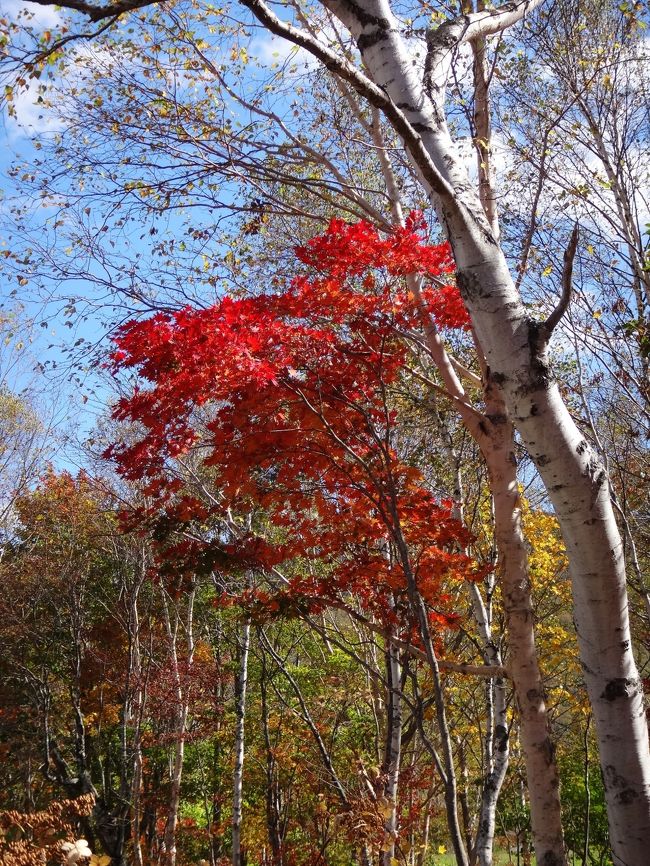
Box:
[310,0,650,852]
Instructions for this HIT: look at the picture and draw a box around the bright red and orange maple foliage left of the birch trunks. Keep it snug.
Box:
[109,214,473,625]
